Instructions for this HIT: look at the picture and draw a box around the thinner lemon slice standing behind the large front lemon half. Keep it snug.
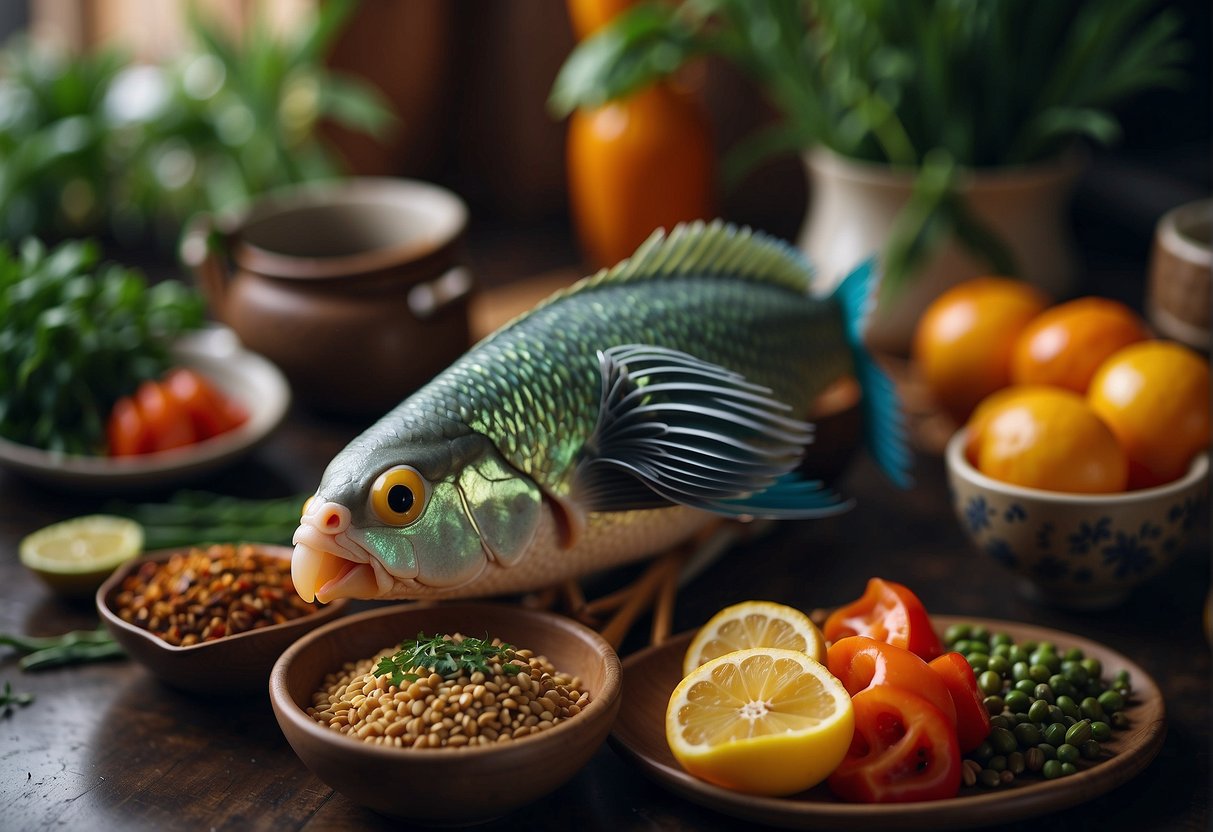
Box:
[683,600,826,676]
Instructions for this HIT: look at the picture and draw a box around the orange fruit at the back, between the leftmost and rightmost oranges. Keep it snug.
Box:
[1010,297,1150,393]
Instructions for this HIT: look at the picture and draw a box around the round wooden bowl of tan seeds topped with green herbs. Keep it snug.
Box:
[269,603,622,825]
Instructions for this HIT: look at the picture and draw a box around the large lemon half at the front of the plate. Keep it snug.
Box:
[666,648,855,796]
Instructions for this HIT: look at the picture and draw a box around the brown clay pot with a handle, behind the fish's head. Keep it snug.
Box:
[182,178,472,415]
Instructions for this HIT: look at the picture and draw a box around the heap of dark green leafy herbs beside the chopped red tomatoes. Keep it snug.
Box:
[0,239,205,455]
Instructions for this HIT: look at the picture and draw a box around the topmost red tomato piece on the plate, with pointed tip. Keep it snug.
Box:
[822,577,944,661]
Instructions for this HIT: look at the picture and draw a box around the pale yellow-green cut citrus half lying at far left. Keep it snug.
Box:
[19,514,143,598]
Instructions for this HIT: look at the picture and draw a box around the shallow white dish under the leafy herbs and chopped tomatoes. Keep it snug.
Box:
[0,326,291,491]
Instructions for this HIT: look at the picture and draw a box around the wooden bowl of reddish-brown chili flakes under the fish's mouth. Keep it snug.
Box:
[97,543,348,694]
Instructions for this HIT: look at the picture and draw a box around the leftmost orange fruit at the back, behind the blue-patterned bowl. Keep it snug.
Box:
[911,278,1048,422]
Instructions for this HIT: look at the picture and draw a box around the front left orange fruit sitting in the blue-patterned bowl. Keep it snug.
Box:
[976,386,1128,494]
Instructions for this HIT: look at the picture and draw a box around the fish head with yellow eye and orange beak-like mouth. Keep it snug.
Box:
[291,433,542,603]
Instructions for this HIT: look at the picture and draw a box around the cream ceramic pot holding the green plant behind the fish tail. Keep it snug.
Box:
[797,148,1083,355]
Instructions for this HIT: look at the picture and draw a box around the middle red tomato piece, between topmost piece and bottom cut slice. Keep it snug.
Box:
[826,636,956,725]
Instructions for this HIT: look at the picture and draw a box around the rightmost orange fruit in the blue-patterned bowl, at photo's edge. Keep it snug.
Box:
[1087,341,1209,489]
